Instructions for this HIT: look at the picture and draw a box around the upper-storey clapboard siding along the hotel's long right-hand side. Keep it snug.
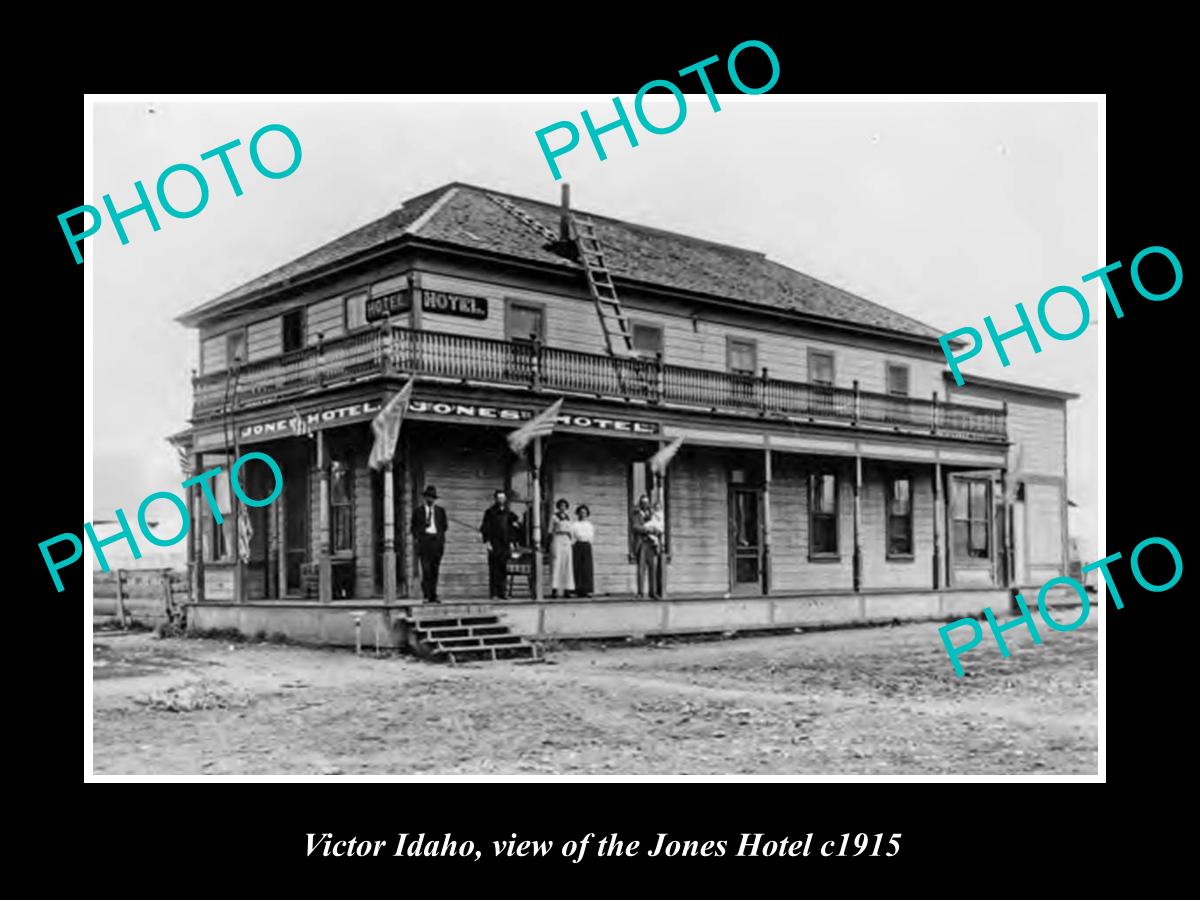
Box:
[421,275,944,398]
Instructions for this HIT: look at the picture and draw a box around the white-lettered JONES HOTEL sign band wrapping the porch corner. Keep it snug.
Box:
[238,400,659,442]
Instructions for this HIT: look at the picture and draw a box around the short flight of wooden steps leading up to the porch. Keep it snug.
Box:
[400,604,539,665]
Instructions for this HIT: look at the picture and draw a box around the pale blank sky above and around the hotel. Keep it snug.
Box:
[88,94,1099,566]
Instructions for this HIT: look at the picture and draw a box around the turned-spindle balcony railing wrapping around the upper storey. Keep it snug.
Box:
[193,326,1007,440]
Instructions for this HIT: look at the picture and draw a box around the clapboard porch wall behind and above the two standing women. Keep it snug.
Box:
[545,436,636,594]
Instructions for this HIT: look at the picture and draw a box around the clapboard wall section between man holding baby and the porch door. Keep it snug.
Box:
[667,446,730,594]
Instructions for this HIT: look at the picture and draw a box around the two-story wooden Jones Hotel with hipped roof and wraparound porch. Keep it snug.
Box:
[174,184,1074,642]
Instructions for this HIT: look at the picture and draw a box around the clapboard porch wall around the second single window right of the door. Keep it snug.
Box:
[862,461,934,590]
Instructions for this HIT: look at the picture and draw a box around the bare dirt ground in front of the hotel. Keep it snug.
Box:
[92,617,1097,775]
